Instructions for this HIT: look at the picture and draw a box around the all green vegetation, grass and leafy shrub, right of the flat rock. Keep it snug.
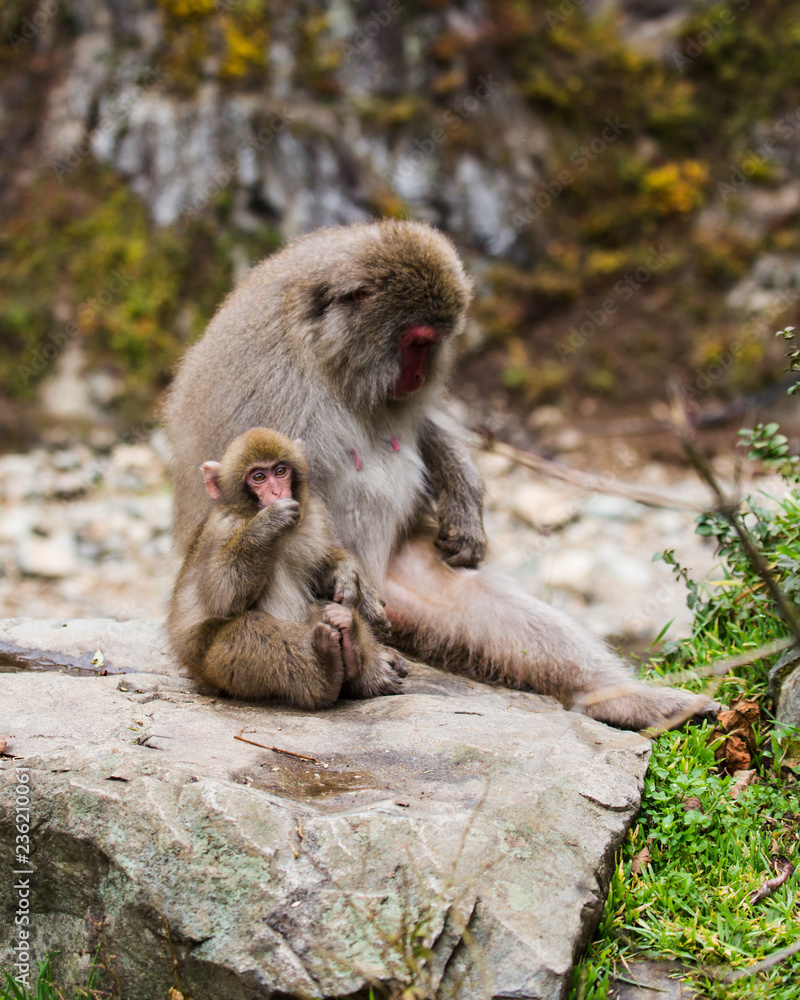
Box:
[572,406,800,1000]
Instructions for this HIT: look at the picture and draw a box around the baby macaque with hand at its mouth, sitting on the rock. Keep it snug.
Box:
[167,427,406,709]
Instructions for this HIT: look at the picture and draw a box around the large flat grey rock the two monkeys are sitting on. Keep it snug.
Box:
[0,619,649,1000]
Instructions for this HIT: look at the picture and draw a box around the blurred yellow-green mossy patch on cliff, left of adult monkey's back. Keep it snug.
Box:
[0,162,277,422]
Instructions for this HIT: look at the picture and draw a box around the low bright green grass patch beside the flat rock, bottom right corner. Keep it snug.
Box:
[573,725,800,1000]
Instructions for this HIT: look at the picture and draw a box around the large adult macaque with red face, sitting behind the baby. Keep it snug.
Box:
[166,221,711,728]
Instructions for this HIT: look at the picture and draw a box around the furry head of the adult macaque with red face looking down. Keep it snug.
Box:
[304,222,471,415]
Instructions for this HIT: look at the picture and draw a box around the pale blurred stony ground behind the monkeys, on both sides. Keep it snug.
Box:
[0,433,764,644]
